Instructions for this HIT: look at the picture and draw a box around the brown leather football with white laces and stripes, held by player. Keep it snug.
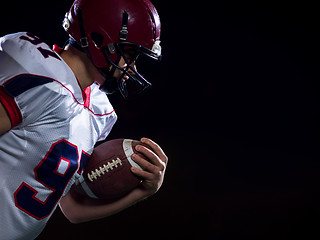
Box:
[75,139,150,199]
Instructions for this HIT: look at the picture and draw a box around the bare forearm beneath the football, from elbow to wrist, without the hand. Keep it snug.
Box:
[60,189,146,223]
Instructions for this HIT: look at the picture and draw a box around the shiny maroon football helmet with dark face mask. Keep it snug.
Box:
[63,0,161,98]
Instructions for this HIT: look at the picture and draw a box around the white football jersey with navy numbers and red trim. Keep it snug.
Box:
[0,32,117,240]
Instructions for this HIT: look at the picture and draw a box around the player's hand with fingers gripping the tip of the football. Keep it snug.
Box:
[131,138,168,197]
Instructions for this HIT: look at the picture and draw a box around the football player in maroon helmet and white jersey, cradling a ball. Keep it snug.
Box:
[0,0,167,240]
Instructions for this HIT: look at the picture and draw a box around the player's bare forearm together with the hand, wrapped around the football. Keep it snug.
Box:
[60,139,168,223]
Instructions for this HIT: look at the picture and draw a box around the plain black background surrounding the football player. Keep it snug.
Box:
[0,0,320,240]
